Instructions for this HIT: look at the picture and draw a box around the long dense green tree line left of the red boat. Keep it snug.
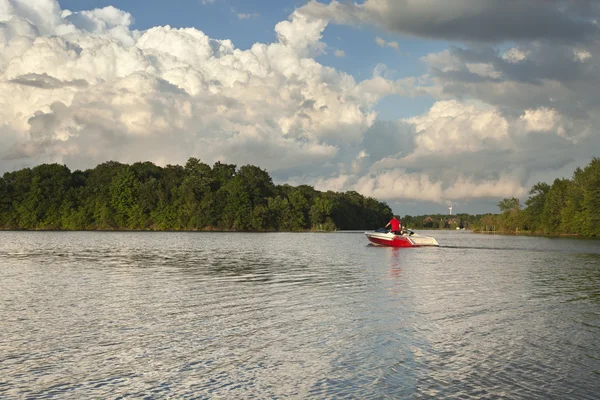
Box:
[0,158,392,231]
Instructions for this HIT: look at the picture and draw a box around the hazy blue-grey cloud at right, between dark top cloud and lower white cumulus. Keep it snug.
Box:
[423,41,600,140]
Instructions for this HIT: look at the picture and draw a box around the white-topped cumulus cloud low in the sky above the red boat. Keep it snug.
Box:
[314,88,600,205]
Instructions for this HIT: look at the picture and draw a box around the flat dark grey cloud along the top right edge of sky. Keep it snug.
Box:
[299,0,600,42]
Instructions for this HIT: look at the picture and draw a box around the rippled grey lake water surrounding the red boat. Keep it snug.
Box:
[0,231,600,399]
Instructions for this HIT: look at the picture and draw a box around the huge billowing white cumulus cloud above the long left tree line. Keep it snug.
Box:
[0,0,378,172]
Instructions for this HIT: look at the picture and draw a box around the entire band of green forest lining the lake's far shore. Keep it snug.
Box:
[0,158,600,237]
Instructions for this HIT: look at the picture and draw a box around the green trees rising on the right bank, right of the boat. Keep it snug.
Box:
[475,158,600,237]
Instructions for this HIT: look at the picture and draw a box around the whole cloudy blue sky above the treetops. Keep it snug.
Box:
[0,0,600,215]
